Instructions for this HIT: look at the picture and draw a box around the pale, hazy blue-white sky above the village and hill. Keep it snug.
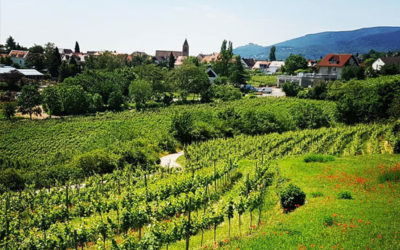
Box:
[0,0,400,55]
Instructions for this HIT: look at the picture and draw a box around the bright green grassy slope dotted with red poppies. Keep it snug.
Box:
[172,155,400,249]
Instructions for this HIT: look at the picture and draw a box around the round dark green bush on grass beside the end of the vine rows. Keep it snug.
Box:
[280,183,306,211]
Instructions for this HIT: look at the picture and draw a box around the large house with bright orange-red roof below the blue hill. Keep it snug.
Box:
[318,54,359,79]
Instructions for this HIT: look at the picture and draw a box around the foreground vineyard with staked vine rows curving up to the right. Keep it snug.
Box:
[0,122,396,249]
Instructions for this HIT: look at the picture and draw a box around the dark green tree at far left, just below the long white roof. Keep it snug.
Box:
[18,84,42,119]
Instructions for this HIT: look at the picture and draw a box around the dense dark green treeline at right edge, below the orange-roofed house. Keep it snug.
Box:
[282,75,400,124]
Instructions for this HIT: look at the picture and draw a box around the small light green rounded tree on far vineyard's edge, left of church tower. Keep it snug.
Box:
[129,80,152,110]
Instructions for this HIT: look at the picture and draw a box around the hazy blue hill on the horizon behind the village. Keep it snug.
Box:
[234,27,400,60]
